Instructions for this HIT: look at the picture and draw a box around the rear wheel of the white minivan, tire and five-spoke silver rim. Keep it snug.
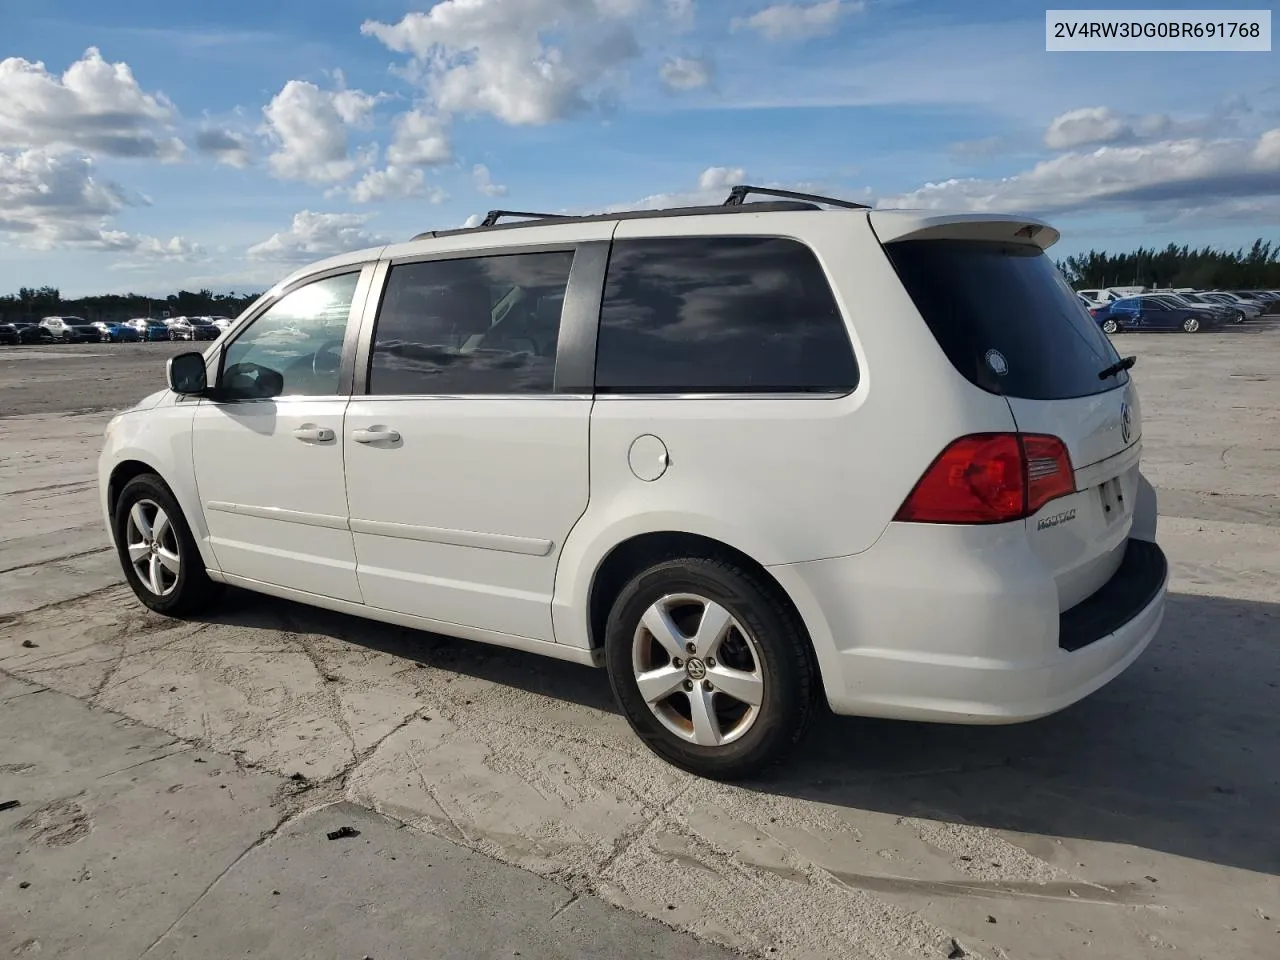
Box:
[604,557,818,780]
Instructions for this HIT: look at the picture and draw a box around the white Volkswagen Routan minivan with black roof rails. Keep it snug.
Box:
[99,187,1167,778]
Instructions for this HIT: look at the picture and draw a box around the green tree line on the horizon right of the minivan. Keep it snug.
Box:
[1059,238,1280,291]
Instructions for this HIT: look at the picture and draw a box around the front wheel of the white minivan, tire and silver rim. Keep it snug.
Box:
[114,474,218,617]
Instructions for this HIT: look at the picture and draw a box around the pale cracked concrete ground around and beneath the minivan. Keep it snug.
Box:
[0,332,1280,960]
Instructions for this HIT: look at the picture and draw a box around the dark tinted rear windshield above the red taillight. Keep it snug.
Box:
[884,241,1129,399]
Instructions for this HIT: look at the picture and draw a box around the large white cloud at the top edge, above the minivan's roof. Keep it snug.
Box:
[361,0,645,124]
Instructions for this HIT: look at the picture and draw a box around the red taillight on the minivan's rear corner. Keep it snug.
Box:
[893,433,1075,524]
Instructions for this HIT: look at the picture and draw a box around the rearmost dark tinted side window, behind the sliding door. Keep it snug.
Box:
[595,237,858,393]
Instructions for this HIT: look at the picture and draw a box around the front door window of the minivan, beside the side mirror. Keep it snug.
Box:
[219,271,360,399]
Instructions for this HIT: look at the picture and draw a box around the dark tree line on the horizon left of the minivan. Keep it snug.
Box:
[0,287,261,323]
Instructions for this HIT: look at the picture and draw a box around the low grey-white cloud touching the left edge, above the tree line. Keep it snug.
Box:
[0,150,202,253]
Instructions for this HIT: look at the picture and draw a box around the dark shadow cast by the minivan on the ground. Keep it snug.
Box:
[199,593,1280,874]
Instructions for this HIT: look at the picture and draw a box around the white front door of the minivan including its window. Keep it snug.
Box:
[192,266,372,603]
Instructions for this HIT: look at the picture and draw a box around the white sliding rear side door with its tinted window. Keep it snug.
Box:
[343,248,594,641]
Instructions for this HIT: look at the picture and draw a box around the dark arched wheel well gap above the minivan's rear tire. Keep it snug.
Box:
[588,531,817,667]
